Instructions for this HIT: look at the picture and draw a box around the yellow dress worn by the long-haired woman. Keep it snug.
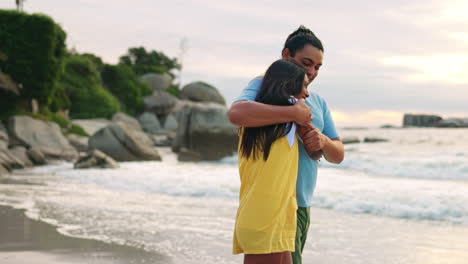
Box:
[233,136,299,254]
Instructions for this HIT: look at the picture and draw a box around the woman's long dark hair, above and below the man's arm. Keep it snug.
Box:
[239,60,306,160]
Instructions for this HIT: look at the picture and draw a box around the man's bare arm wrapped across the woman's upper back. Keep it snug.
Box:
[228,99,312,127]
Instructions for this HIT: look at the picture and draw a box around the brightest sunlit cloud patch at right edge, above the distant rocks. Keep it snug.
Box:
[381,54,468,84]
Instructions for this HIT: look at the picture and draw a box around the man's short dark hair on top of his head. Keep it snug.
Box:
[283,25,323,57]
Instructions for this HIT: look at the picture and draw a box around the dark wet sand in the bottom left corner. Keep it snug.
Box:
[0,205,170,264]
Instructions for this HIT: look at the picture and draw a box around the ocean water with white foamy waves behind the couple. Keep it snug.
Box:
[0,128,468,264]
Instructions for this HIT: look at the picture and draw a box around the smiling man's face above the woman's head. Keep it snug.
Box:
[283,44,323,84]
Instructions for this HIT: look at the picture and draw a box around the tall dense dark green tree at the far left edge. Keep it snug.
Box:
[0,10,66,110]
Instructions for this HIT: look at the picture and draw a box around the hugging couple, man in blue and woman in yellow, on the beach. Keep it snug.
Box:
[229,26,344,264]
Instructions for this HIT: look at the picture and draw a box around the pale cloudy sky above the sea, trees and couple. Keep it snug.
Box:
[0,0,468,126]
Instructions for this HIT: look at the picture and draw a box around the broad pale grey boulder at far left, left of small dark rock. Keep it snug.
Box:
[8,116,78,161]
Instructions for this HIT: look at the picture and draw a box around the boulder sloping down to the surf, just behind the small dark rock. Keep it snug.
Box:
[89,122,161,161]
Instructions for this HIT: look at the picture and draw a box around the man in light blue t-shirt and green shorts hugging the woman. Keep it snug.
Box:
[229,26,344,264]
